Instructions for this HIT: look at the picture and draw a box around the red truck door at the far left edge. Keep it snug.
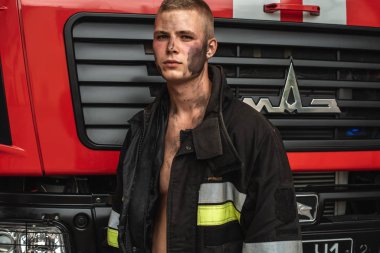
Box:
[0,1,43,176]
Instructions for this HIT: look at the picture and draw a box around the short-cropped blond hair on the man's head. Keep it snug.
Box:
[157,0,214,39]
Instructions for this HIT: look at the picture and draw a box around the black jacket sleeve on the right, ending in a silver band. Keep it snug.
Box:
[241,128,302,253]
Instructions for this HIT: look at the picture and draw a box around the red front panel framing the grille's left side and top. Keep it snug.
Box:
[17,1,231,174]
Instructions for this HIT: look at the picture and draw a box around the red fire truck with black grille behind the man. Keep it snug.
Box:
[0,0,380,253]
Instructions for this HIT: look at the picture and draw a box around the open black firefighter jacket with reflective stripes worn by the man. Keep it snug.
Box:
[107,66,302,253]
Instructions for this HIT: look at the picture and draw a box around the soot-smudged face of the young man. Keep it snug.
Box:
[153,10,207,82]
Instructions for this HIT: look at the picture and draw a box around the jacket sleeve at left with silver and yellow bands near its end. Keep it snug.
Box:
[107,131,131,248]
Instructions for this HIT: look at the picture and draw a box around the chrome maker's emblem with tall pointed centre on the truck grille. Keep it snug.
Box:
[243,61,341,113]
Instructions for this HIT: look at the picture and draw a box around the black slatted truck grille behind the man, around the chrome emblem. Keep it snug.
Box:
[65,14,380,151]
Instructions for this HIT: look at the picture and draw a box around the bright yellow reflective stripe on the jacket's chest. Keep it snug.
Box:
[197,202,240,226]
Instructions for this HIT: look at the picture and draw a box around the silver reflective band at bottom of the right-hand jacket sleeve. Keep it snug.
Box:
[243,241,302,253]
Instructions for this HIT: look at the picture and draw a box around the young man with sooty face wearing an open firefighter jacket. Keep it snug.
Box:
[108,0,302,253]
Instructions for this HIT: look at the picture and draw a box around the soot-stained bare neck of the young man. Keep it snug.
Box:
[167,67,212,123]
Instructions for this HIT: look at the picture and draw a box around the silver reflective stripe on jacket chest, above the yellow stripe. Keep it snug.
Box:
[198,182,247,212]
